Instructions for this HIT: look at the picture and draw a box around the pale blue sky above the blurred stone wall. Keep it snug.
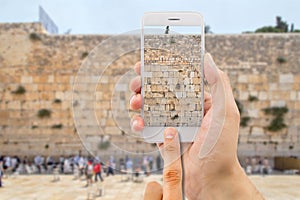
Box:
[0,0,300,34]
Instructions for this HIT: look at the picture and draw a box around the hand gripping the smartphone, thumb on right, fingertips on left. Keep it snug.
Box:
[130,54,259,200]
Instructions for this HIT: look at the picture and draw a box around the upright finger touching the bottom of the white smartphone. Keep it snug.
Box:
[163,128,182,200]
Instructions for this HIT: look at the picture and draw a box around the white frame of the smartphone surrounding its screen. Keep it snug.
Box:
[141,12,205,143]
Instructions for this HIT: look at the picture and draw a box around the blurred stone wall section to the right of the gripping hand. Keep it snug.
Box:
[206,34,300,156]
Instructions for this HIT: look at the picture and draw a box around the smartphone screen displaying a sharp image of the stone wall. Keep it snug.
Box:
[142,26,203,127]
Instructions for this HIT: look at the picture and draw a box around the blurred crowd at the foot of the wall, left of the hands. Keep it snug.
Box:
[0,155,163,187]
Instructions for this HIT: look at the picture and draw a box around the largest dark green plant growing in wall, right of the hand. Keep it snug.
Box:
[263,106,289,132]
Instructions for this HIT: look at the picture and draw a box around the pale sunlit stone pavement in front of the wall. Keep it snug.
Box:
[0,175,300,200]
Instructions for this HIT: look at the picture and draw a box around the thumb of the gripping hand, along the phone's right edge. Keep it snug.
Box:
[196,54,239,159]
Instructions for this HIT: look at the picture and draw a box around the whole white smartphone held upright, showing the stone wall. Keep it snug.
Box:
[141,12,205,143]
